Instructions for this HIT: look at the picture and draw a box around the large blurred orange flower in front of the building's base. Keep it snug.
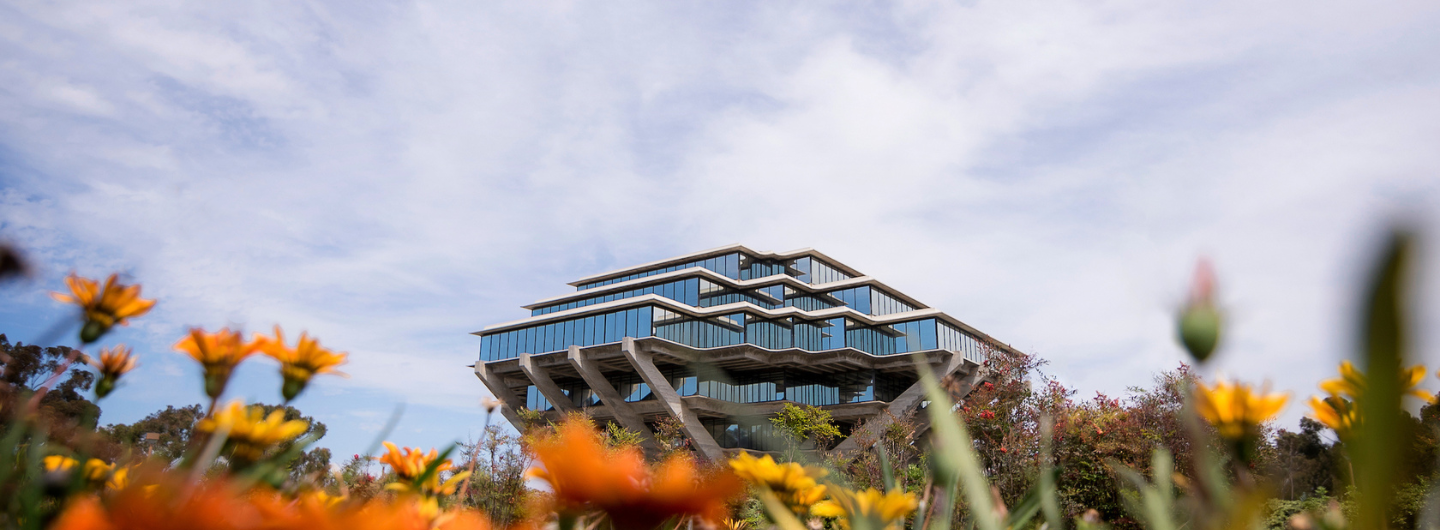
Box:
[527,421,744,530]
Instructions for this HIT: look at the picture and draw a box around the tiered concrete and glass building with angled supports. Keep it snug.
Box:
[475,245,1009,458]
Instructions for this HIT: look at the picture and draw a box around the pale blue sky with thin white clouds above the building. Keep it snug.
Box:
[0,0,1440,457]
